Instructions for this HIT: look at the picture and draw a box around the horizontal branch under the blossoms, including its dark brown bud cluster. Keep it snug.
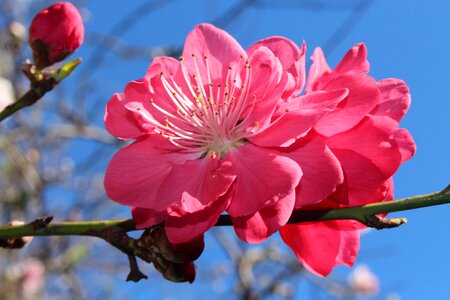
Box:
[0,185,450,282]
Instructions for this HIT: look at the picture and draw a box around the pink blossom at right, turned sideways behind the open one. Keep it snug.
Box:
[280,44,415,275]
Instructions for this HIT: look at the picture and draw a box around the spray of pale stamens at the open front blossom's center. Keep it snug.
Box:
[150,54,256,157]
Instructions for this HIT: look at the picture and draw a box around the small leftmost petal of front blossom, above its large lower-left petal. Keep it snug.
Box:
[104,94,143,140]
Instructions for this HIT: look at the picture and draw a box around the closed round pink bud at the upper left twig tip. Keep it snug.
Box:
[28,2,84,69]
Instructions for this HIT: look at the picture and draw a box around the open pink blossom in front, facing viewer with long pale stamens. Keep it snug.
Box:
[105,24,348,243]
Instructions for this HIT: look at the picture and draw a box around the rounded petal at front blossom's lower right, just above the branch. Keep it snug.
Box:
[283,135,344,208]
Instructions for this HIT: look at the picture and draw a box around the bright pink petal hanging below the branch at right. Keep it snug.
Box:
[280,220,359,276]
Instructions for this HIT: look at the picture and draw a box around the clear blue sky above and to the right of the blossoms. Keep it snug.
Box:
[67,0,450,300]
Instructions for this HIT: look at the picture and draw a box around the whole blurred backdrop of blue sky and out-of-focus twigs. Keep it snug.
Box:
[0,0,450,300]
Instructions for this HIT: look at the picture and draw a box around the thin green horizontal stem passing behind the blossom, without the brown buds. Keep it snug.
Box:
[0,186,450,238]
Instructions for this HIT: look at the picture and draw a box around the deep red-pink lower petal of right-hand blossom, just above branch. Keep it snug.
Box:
[332,149,388,206]
